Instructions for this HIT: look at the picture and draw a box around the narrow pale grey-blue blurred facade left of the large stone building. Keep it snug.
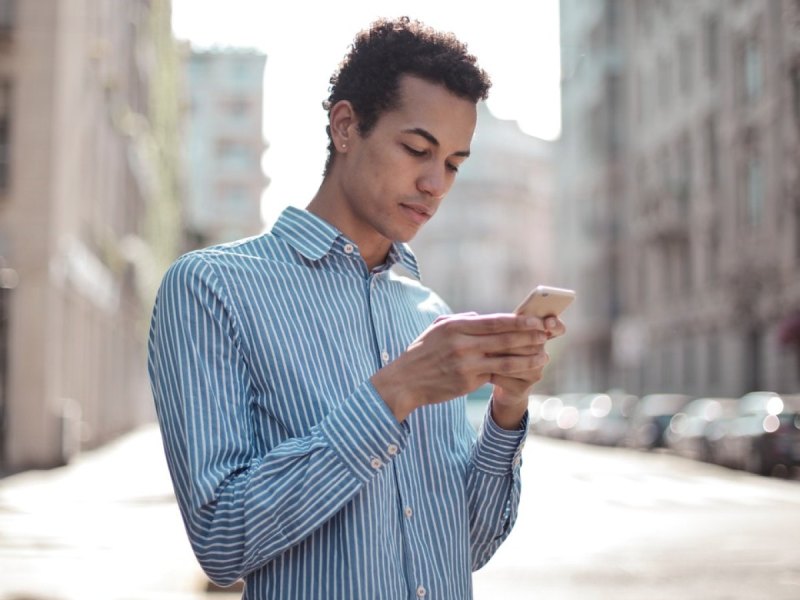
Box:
[554,1,627,391]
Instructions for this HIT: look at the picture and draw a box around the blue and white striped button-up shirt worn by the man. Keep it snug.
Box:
[148,208,527,600]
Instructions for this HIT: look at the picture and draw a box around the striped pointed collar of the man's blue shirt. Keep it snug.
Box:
[272,206,419,279]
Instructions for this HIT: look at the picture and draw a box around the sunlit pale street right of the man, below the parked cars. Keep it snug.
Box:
[475,438,800,600]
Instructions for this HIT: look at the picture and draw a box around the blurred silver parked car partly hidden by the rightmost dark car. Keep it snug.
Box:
[664,398,739,462]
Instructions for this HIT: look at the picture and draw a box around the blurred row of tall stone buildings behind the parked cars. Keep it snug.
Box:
[557,0,800,395]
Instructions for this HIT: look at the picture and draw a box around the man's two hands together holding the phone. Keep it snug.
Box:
[372,314,564,429]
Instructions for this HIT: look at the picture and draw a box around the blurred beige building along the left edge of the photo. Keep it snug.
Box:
[0,0,179,472]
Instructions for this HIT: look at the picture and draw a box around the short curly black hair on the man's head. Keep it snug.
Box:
[322,17,492,175]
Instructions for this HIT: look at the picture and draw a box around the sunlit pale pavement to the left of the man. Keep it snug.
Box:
[0,425,231,600]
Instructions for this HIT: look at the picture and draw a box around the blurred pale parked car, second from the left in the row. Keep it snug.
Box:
[569,392,638,446]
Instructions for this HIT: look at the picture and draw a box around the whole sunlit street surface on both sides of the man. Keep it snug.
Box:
[0,426,800,600]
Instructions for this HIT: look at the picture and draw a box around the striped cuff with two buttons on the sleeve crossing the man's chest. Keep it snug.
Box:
[320,381,409,482]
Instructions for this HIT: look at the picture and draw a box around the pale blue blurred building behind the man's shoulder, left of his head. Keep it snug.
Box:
[184,49,268,247]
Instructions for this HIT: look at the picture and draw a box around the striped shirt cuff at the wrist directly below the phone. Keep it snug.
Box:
[472,402,528,476]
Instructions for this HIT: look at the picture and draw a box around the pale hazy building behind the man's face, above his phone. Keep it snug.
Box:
[411,103,560,312]
